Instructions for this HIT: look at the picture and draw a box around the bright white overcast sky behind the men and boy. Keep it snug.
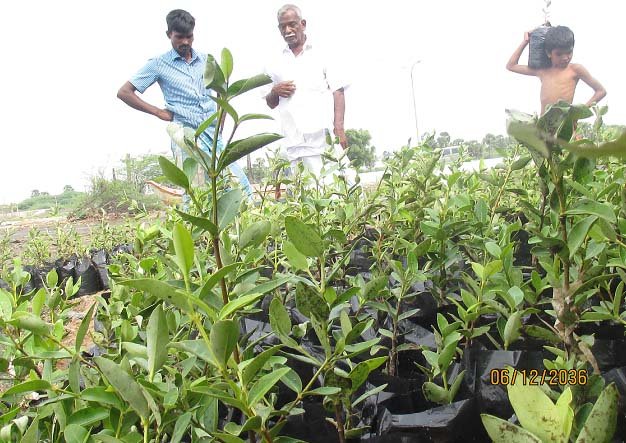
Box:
[0,0,626,204]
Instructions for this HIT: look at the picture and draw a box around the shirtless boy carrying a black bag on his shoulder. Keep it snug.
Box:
[506,26,606,114]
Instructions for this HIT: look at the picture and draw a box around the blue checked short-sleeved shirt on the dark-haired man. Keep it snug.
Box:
[130,48,216,132]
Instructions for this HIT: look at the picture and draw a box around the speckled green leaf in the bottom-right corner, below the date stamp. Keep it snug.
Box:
[576,383,619,443]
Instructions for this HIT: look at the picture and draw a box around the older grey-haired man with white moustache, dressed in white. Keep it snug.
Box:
[265,4,348,179]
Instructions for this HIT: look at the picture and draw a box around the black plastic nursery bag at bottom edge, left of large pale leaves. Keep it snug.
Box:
[376,398,486,443]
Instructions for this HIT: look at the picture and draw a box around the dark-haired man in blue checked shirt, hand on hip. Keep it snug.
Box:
[117,9,252,198]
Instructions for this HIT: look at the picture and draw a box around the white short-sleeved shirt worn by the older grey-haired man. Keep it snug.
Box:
[265,38,348,159]
